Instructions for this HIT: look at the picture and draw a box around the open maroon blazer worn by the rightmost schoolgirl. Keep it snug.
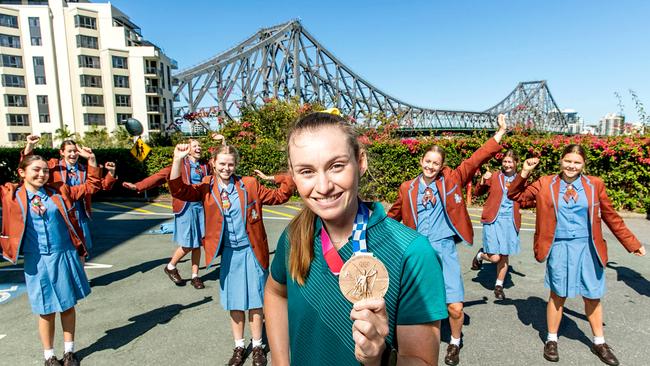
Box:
[508,174,641,266]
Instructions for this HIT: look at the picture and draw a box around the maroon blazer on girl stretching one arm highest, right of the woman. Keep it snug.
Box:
[388,138,502,245]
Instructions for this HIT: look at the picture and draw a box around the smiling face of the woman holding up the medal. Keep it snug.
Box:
[289,126,367,227]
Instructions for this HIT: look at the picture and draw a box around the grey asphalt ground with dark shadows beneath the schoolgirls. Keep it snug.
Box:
[0,202,650,365]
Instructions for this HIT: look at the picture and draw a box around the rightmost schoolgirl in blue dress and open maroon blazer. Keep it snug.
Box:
[508,145,646,366]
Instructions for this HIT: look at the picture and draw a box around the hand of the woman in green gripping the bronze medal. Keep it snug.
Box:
[350,299,388,365]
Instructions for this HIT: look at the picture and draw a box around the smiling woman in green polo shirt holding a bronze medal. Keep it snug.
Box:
[264,113,447,366]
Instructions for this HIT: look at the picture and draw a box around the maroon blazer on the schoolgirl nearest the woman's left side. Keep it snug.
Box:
[169,174,296,270]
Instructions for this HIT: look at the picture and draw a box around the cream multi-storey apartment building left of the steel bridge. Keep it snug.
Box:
[0,0,177,146]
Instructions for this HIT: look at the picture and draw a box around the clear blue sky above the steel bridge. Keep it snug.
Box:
[111,0,650,123]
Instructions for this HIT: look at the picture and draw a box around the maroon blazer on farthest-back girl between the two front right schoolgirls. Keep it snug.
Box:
[474,170,535,232]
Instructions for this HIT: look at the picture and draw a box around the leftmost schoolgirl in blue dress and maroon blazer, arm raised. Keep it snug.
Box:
[0,148,107,366]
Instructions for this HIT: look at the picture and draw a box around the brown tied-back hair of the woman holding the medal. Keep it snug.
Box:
[287,112,361,286]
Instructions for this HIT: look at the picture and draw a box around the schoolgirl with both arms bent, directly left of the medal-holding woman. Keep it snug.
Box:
[169,144,295,366]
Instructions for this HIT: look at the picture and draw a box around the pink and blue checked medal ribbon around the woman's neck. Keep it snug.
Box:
[320,202,370,276]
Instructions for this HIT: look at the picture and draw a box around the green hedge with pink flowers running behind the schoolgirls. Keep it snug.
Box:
[0,132,650,212]
